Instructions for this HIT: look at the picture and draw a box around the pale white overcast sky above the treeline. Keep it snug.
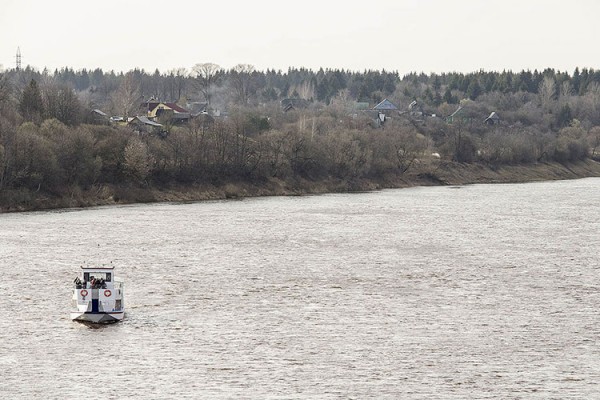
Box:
[0,0,600,74]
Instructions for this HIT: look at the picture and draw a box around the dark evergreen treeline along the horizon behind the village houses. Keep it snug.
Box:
[4,63,600,111]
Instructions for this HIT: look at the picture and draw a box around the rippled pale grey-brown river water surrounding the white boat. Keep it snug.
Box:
[0,178,600,399]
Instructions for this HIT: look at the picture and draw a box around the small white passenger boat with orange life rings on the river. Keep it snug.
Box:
[71,266,125,324]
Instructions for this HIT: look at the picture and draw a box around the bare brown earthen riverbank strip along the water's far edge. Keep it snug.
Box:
[0,160,600,213]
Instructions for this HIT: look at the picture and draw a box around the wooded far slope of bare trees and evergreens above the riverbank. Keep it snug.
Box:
[0,63,600,209]
